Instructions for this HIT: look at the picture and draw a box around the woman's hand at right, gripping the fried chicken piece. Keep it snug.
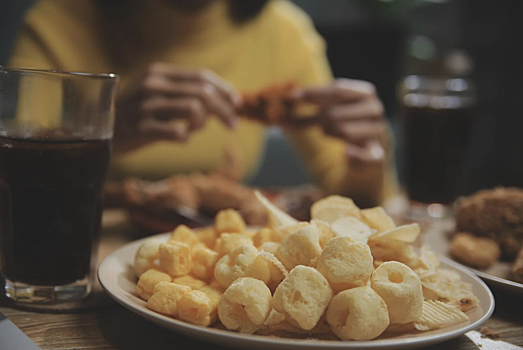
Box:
[296,79,387,166]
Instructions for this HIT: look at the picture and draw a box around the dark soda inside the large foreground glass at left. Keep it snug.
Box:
[0,137,111,286]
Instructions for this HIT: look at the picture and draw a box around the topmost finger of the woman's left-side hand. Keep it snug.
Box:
[149,63,240,106]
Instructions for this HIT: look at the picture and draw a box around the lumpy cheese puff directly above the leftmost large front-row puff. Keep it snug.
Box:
[214,245,271,288]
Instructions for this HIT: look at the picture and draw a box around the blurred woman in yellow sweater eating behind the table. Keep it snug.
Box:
[9,0,397,206]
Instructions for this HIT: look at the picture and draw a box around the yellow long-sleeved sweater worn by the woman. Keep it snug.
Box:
[8,0,397,204]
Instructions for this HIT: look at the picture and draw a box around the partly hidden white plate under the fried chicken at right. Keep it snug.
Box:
[423,228,523,294]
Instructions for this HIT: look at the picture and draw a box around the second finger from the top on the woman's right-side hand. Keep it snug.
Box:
[324,98,384,121]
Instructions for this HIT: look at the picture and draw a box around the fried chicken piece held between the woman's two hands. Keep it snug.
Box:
[238,82,296,125]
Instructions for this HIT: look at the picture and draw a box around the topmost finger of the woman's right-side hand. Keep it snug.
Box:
[295,79,376,106]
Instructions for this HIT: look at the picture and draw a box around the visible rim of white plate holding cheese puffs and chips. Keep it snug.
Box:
[98,234,494,350]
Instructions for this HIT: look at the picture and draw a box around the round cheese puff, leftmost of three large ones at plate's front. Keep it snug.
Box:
[218,277,272,334]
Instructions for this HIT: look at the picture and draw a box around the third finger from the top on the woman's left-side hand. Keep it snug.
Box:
[142,96,208,131]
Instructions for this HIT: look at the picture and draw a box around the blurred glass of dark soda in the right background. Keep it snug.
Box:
[398,75,476,223]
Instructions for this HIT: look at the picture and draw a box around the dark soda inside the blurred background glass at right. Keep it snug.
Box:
[400,106,474,204]
